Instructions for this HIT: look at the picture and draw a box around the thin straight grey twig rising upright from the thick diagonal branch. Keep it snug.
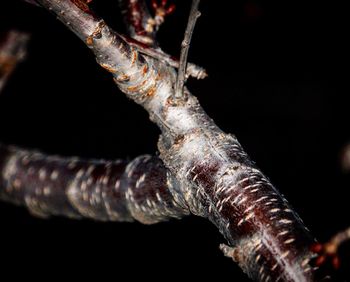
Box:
[175,0,201,99]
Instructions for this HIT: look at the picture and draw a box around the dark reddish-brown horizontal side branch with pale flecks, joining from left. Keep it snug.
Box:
[0,146,188,224]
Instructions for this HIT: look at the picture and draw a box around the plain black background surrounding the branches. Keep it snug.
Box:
[0,0,350,281]
